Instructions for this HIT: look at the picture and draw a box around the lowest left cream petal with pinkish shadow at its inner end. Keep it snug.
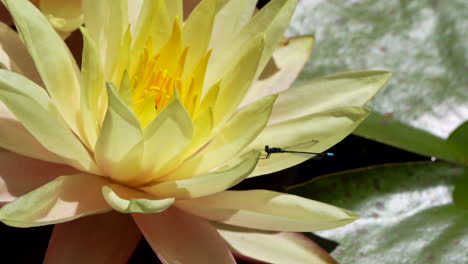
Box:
[0,174,111,227]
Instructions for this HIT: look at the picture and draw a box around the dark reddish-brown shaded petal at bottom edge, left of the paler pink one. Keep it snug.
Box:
[44,212,141,264]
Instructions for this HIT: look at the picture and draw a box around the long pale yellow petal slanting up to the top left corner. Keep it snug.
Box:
[4,0,82,136]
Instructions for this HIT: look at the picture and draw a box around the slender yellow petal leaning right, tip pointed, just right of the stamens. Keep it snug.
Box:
[213,35,265,126]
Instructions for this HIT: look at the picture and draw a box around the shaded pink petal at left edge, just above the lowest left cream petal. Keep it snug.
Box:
[0,151,76,204]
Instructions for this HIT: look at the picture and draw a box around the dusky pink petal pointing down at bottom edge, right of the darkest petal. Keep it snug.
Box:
[133,207,235,264]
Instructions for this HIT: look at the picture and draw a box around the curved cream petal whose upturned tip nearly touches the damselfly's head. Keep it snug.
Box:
[141,151,260,199]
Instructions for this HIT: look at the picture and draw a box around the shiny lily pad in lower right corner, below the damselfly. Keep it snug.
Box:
[290,162,468,264]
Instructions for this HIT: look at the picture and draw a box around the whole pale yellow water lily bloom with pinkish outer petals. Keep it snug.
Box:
[0,0,389,263]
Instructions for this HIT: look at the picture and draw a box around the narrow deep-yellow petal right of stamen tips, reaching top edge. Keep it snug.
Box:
[183,0,217,74]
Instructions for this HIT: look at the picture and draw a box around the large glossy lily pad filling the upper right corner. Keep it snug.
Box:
[288,0,468,158]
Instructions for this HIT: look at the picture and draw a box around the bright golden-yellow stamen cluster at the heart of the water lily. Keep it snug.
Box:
[127,19,210,127]
